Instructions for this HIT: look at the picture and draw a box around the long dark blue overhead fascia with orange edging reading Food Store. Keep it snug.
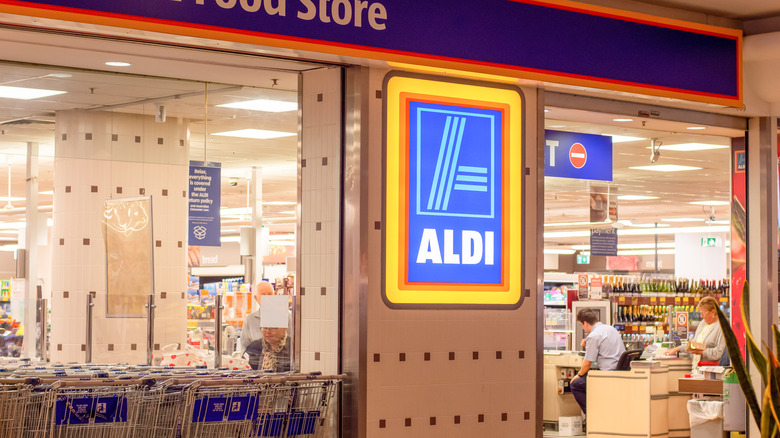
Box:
[0,0,742,106]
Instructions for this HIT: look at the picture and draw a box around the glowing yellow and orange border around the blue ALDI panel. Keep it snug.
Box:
[382,72,525,309]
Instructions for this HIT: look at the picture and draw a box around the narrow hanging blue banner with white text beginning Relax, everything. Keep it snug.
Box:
[188,161,222,246]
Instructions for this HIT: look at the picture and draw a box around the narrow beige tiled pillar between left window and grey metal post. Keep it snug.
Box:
[298,68,341,374]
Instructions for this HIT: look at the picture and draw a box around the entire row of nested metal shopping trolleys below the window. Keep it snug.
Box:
[0,373,343,438]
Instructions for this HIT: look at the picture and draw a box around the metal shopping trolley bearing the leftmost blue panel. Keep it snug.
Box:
[23,379,152,438]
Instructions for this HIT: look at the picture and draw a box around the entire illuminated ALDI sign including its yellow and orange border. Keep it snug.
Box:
[383,75,524,308]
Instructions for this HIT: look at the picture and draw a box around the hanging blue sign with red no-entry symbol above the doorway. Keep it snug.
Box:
[544,129,612,181]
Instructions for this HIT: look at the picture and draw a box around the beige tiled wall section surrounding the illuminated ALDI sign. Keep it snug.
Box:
[354,70,543,438]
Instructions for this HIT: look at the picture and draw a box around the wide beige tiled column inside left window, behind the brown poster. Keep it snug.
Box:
[50,111,189,364]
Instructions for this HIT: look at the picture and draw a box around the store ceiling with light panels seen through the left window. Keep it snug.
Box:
[0,29,326,245]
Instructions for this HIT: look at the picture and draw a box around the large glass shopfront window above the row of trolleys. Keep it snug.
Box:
[0,32,340,371]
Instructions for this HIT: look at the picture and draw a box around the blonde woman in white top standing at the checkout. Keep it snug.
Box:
[666,297,726,365]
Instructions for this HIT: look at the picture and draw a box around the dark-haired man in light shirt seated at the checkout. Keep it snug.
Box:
[569,309,626,414]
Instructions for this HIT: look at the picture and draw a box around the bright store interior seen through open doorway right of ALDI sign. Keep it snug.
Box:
[544,104,744,430]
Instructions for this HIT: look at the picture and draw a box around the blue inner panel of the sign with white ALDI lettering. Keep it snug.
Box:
[406,100,503,284]
